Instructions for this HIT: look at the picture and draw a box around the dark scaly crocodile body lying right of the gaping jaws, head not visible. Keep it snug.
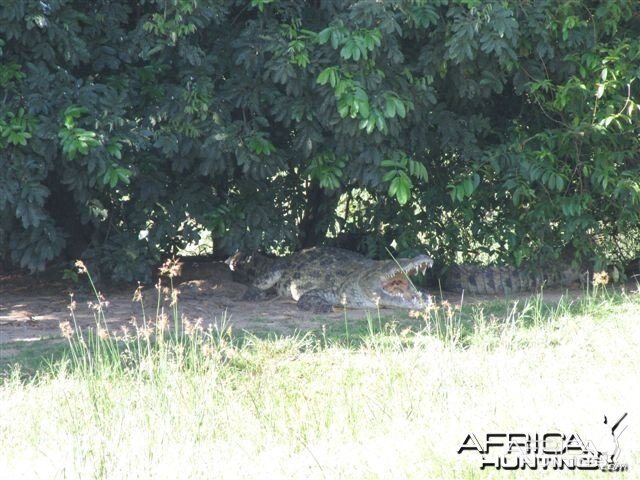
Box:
[441,261,586,295]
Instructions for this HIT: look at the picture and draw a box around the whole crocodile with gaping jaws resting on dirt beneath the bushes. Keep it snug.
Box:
[226,247,433,312]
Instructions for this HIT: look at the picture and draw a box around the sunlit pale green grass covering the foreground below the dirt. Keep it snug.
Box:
[0,272,640,479]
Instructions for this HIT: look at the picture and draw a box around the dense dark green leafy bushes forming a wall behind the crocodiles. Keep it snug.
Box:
[0,0,640,278]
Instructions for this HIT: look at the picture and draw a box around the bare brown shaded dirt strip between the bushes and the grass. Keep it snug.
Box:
[0,260,604,356]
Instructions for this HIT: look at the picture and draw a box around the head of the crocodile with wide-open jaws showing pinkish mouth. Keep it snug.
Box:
[347,255,433,309]
